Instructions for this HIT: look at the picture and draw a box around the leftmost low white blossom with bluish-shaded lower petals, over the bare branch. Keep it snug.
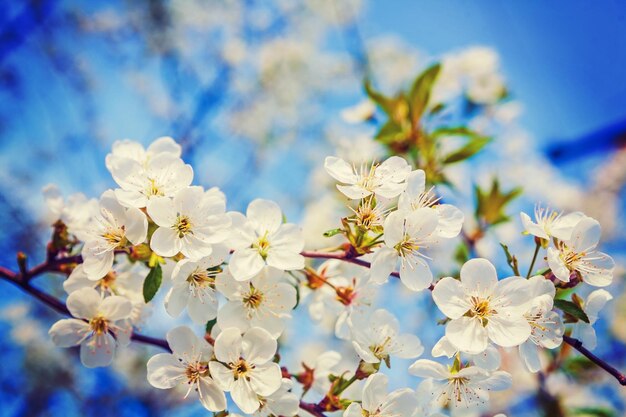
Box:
[48,288,132,368]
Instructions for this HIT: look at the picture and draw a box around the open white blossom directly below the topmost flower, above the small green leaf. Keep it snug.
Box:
[147,187,230,260]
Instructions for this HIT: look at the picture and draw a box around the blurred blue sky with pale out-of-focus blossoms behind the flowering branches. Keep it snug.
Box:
[0,0,626,417]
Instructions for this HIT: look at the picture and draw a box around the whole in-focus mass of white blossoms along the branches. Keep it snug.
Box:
[45,137,614,417]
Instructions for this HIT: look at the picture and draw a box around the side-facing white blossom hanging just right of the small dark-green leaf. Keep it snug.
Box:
[165,245,228,324]
